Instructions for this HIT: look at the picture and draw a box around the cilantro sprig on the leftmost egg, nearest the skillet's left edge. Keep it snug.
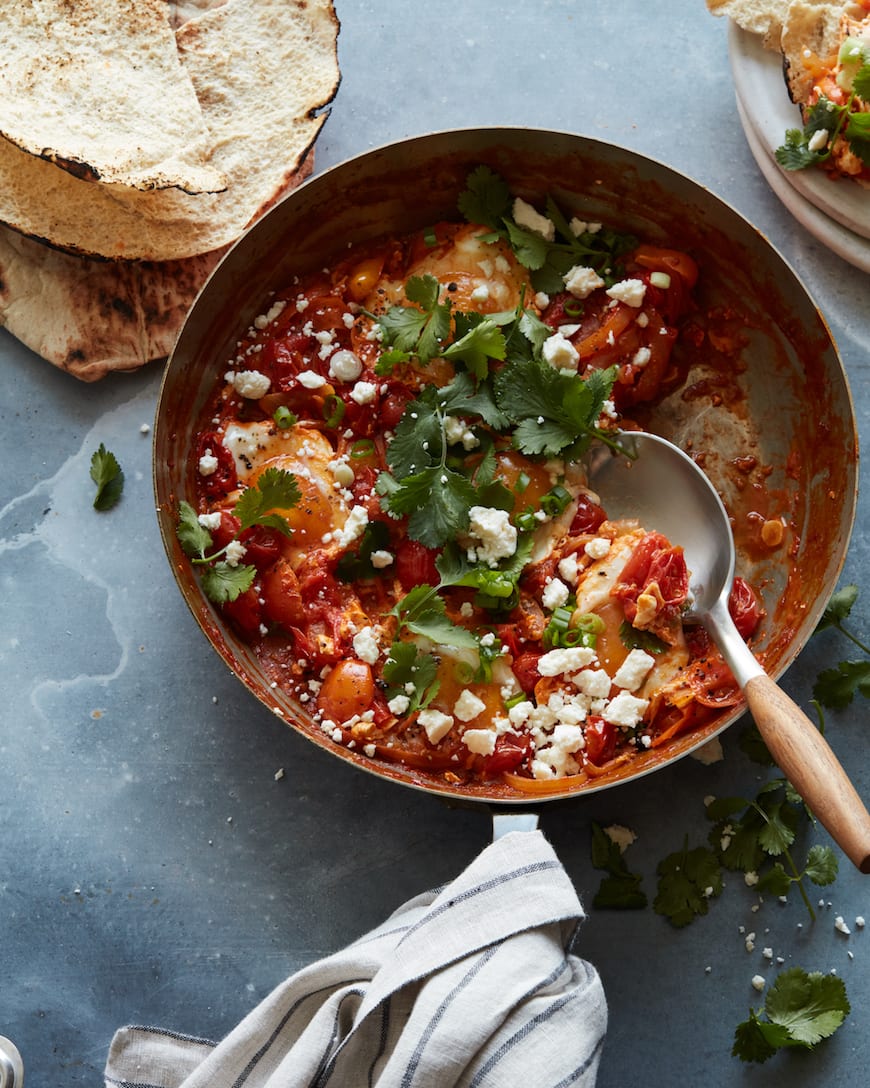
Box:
[175,468,300,604]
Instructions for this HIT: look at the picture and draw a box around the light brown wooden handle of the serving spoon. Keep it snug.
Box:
[744,675,870,873]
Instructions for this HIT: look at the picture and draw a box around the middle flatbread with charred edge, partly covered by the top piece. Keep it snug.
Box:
[0,0,339,261]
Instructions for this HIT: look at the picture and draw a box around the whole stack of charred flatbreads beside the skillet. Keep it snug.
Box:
[0,0,339,381]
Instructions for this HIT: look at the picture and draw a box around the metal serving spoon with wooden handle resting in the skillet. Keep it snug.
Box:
[588,431,870,873]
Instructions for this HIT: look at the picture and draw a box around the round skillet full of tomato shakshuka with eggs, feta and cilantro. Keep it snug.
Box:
[154,127,857,803]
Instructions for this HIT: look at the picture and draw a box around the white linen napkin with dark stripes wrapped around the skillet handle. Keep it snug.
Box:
[105,831,607,1088]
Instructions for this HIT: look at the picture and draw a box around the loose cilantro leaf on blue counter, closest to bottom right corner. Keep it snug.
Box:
[731,967,852,1062]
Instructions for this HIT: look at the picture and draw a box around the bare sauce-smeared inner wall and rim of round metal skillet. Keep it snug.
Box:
[154,127,857,806]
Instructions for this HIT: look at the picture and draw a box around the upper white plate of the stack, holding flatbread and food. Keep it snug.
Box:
[728,23,870,238]
